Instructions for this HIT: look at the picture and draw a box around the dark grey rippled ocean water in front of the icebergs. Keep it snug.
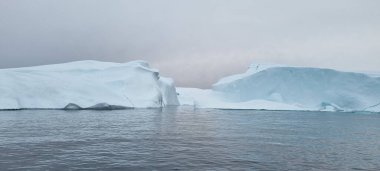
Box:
[0,108,380,171]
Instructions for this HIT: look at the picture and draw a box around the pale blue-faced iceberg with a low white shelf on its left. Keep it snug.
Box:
[177,64,380,112]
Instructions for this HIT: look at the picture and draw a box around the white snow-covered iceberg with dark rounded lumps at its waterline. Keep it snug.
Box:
[0,61,179,109]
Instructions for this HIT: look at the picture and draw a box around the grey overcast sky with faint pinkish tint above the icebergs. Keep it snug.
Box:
[0,0,380,88]
